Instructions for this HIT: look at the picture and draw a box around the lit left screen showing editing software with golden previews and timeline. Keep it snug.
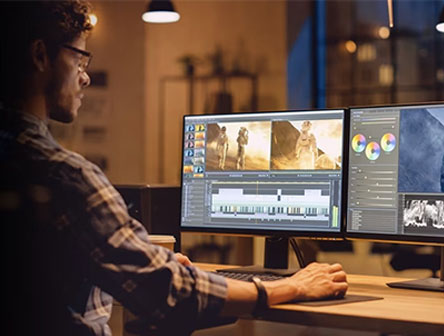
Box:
[181,110,344,233]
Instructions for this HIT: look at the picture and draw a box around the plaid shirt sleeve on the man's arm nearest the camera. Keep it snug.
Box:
[54,154,227,331]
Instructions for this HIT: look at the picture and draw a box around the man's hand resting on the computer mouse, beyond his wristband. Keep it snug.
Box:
[289,263,348,300]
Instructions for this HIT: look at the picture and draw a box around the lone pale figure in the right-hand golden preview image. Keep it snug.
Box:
[295,120,318,169]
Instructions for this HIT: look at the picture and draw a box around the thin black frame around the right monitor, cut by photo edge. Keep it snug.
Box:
[344,101,444,246]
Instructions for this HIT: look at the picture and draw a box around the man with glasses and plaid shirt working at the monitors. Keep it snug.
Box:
[0,0,347,336]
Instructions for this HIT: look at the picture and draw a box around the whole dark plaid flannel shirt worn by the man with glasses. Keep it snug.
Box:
[0,111,227,335]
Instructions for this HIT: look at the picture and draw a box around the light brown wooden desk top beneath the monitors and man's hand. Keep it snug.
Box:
[195,263,444,336]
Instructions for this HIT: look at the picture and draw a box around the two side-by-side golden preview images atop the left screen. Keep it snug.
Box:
[206,119,342,171]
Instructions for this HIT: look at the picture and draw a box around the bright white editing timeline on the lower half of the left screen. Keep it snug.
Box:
[211,182,339,230]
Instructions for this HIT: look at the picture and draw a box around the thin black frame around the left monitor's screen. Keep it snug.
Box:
[180,107,350,240]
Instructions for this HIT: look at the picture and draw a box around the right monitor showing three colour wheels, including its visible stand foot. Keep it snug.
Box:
[346,102,444,290]
